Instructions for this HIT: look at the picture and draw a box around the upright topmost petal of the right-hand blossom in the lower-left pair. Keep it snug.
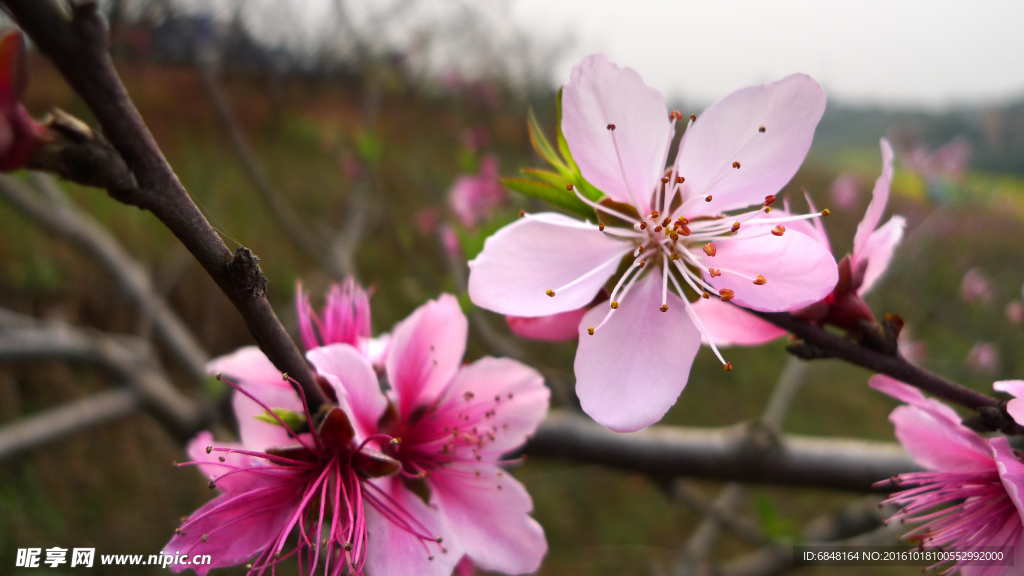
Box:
[385,294,469,416]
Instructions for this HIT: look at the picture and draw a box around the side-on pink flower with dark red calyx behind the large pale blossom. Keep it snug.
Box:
[693,138,906,346]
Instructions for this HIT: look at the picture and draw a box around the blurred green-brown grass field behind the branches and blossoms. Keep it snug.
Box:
[0,54,1024,575]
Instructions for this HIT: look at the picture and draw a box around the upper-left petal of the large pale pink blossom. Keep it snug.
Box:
[562,54,671,207]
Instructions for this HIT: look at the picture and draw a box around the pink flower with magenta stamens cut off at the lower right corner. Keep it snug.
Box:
[869,375,1024,576]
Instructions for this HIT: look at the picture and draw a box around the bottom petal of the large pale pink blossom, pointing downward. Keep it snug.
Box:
[574,274,700,431]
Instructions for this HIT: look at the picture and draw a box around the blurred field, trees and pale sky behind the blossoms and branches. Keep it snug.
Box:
[0,0,1024,576]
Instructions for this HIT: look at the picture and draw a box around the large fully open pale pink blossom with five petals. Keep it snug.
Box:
[469,55,838,431]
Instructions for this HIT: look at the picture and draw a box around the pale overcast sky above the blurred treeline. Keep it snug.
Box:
[511,0,1024,108]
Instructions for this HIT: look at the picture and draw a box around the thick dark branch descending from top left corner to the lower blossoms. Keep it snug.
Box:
[3,0,324,410]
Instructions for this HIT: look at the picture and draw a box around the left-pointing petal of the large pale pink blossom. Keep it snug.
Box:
[469,213,632,317]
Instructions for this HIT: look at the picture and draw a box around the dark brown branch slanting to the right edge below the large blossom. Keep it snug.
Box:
[749,311,1024,434]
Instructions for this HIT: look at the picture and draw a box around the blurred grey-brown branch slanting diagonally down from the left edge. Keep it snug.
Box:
[0,172,209,381]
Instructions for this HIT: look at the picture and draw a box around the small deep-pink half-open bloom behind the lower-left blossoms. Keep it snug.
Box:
[295,277,390,367]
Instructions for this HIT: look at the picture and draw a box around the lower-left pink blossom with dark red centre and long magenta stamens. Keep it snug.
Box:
[164,344,452,576]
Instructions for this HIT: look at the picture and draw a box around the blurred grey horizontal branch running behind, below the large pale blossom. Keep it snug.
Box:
[523,411,921,492]
